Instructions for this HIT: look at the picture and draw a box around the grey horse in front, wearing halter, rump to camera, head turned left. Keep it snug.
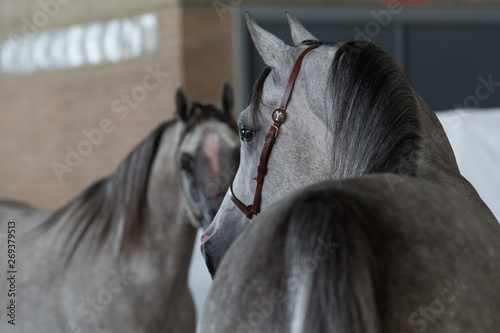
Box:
[202,15,500,333]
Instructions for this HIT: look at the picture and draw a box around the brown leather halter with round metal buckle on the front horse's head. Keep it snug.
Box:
[230,44,319,222]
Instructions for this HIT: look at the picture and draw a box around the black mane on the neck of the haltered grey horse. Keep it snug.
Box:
[327,41,421,178]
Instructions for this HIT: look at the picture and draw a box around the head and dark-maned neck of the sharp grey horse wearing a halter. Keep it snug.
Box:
[202,14,458,275]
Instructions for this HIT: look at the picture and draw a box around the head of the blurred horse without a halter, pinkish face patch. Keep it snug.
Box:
[176,84,239,229]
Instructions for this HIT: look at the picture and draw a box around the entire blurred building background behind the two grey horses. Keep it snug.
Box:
[0,0,500,326]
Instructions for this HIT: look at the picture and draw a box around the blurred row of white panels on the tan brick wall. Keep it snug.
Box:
[1,14,159,74]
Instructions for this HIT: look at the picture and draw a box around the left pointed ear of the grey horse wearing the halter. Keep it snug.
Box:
[246,12,290,68]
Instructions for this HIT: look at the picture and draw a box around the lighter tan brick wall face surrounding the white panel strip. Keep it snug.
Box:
[0,0,182,208]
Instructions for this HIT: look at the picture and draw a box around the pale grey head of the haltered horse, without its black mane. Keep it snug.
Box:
[202,15,335,275]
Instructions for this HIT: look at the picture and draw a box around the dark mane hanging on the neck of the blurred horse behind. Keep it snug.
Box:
[38,120,175,265]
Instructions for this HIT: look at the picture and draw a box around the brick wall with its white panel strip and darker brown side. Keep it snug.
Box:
[0,0,233,208]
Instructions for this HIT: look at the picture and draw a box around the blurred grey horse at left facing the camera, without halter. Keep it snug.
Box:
[0,86,239,333]
